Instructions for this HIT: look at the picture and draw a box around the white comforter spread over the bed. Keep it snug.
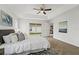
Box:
[4,37,50,54]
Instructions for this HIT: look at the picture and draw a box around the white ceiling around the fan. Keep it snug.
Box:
[0,4,77,20]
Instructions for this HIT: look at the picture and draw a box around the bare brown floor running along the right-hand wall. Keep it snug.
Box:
[49,37,79,55]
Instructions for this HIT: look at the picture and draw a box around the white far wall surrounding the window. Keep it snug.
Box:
[18,19,49,36]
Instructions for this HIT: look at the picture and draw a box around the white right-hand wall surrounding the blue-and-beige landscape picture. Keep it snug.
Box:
[52,6,79,47]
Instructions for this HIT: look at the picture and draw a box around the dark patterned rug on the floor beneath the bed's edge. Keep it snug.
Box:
[13,50,58,55]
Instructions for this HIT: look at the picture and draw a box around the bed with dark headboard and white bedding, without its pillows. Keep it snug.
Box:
[0,29,50,55]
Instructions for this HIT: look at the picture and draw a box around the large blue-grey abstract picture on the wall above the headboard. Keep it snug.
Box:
[0,10,13,26]
